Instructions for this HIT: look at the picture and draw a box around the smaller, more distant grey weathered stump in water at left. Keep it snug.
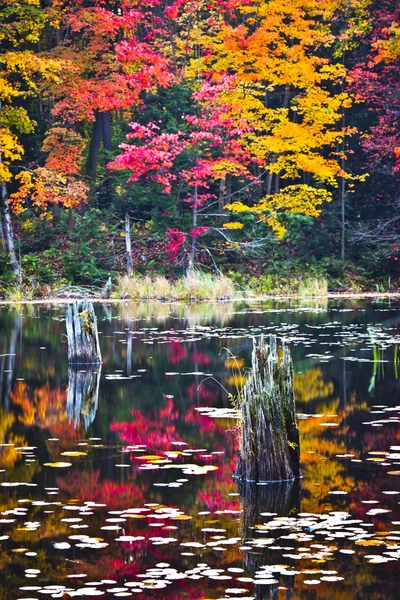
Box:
[66,299,101,365]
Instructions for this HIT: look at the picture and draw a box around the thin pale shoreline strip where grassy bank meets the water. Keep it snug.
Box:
[0,292,400,306]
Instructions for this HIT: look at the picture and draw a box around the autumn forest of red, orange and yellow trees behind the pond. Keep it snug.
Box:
[0,0,400,299]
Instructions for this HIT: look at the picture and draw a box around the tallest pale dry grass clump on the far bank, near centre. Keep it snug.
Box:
[115,271,234,302]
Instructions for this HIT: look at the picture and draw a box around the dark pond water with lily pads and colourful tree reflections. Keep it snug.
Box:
[0,300,400,600]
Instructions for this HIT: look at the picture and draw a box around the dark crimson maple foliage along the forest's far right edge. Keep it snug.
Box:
[348,0,400,248]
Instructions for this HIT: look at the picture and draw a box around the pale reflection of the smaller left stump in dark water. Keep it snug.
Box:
[67,367,101,429]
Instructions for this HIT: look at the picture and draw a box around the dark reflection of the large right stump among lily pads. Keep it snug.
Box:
[238,479,301,600]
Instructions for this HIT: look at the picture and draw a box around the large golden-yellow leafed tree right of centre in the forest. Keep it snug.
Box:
[198,0,368,237]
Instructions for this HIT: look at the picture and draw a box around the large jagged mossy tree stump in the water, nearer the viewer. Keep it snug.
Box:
[235,336,300,482]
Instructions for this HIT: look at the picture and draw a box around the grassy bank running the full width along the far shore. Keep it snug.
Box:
[0,270,400,302]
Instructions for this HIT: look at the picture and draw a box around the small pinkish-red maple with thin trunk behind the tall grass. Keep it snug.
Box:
[110,78,251,269]
